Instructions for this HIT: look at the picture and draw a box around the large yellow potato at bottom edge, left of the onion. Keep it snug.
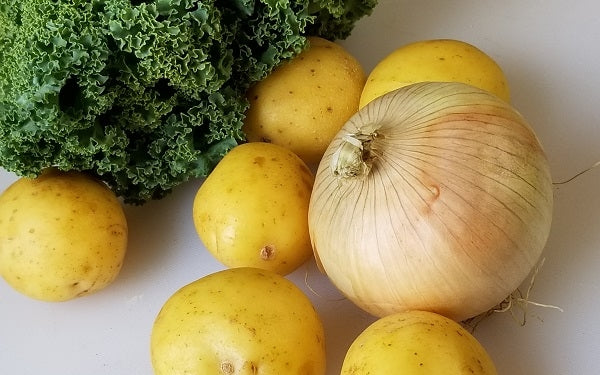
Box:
[151,267,325,375]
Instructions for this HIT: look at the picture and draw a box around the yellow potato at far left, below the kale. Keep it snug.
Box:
[0,169,127,301]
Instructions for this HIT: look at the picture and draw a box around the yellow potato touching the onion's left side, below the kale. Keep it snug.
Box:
[193,142,314,274]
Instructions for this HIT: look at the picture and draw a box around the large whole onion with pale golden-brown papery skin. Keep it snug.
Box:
[309,82,553,321]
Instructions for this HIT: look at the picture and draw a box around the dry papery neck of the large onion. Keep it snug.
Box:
[330,132,377,179]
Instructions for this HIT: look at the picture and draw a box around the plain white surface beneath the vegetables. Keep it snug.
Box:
[0,0,600,375]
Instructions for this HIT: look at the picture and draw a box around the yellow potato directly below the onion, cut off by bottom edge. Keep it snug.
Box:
[341,311,497,375]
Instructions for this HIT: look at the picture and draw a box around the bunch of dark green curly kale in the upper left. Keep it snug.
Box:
[0,0,375,203]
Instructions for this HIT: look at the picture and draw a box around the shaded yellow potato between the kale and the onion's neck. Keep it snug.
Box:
[243,37,366,165]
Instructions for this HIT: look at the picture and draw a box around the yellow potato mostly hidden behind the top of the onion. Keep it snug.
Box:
[360,39,510,108]
